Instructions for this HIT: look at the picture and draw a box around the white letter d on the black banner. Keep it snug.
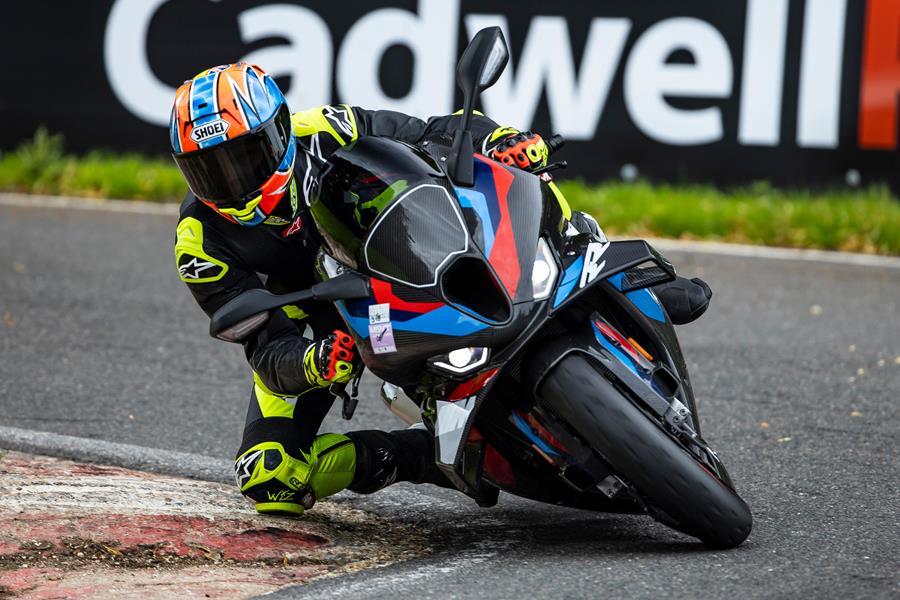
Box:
[336,0,459,116]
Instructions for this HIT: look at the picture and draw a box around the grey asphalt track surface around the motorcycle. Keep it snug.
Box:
[0,198,900,598]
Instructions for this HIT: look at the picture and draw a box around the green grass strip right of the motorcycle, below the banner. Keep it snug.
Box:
[560,182,900,255]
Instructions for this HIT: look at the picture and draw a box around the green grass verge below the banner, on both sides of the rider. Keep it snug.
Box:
[0,129,900,256]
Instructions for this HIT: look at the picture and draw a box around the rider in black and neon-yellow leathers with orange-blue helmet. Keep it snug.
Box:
[170,63,711,515]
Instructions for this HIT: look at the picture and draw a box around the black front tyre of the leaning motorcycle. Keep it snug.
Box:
[539,354,753,548]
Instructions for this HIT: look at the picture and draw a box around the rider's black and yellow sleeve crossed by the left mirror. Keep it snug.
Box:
[175,204,313,396]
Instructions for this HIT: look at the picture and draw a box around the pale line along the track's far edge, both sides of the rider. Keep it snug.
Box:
[0,194,900,269]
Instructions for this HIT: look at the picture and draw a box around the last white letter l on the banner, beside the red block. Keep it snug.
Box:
[797,0,847,148]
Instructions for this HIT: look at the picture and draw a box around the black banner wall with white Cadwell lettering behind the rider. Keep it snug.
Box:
[0,0,900,185]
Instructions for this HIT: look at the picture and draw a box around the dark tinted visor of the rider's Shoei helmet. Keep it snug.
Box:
[172,104,293,206]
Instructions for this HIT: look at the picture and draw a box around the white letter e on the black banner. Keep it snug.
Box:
[625,17,732,146]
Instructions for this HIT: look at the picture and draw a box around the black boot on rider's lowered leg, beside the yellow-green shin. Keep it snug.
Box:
[347,428,454,494]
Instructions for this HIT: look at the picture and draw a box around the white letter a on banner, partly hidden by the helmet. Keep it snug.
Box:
[238,4,334,111]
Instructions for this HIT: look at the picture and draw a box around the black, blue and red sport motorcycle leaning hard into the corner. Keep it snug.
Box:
[210,27,752,548]
